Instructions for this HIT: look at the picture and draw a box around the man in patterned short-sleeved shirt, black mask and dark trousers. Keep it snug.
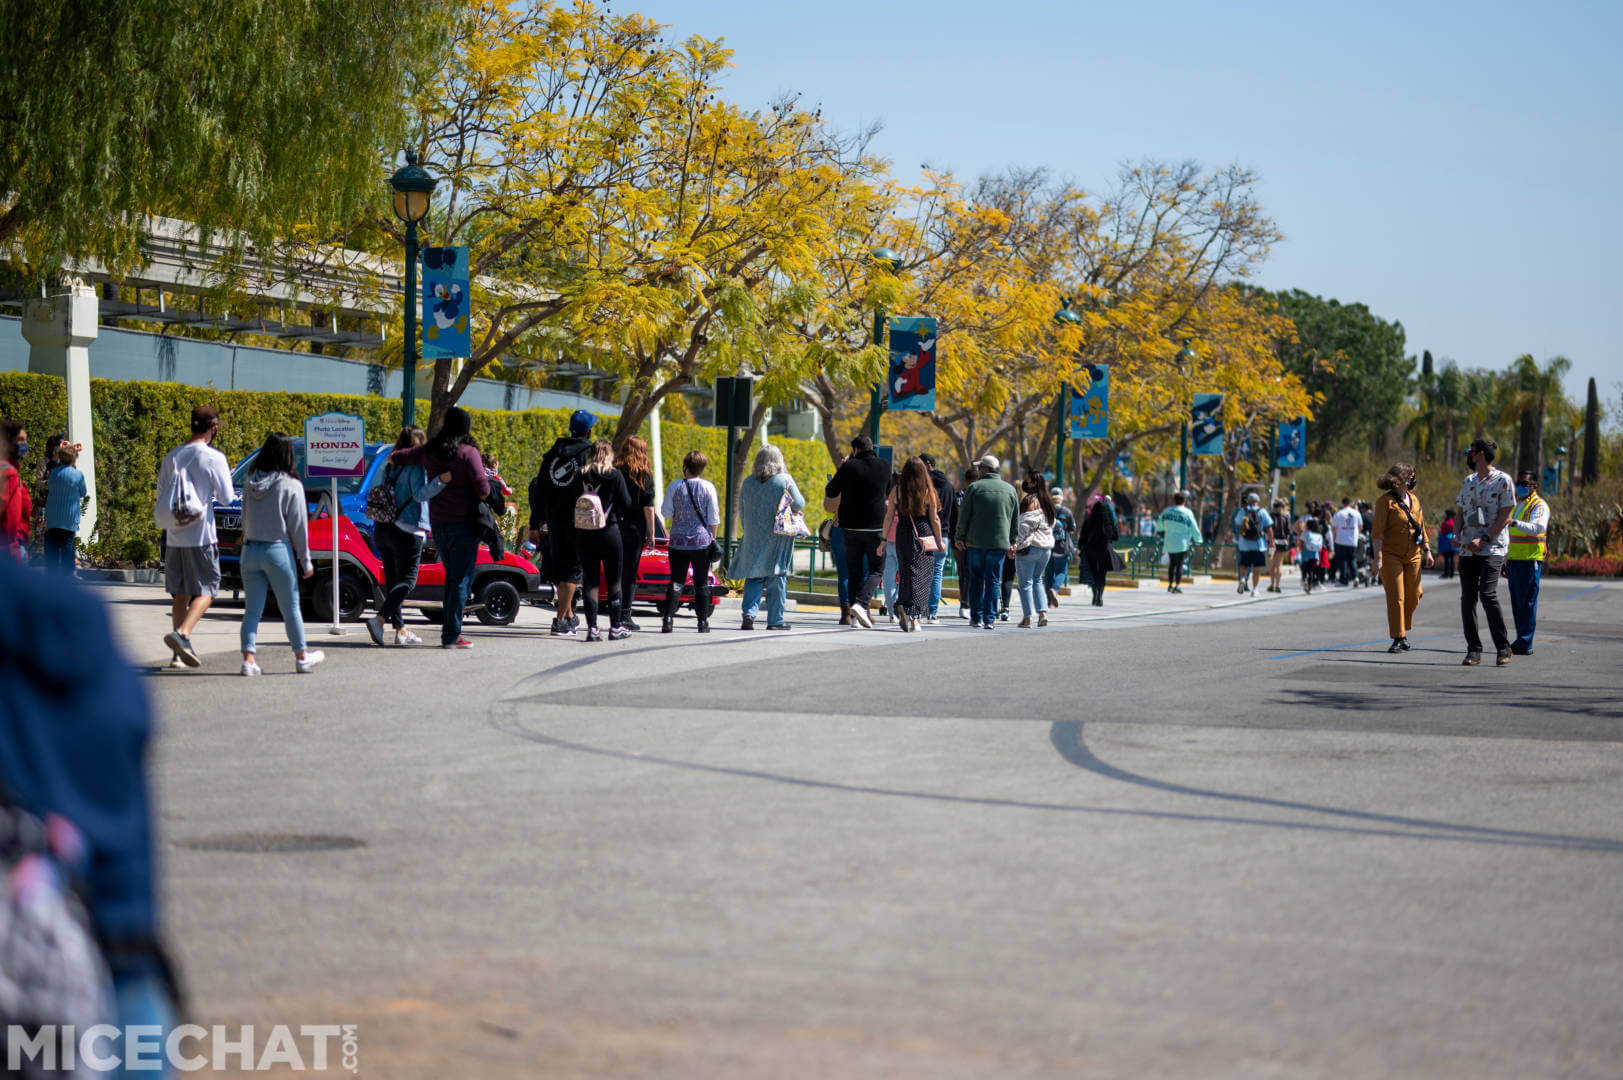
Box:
[1456,438,1516,667]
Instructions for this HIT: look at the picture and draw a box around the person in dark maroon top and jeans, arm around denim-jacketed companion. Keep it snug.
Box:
[390,406,490,648]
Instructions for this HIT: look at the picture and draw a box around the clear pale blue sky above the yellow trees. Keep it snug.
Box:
[629,0,1623,401]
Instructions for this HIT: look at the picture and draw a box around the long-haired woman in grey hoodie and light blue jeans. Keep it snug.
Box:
[240,432,326,676]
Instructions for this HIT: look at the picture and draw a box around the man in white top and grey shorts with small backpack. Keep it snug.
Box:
[153,404,234,667]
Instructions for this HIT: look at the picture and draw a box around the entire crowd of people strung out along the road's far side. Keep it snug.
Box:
[0,406,1550,676]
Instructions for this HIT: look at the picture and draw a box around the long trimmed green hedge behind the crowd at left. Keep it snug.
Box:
[0,372,831,562]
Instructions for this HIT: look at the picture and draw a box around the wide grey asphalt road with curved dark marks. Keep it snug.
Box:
[126,581,1623,1078]
